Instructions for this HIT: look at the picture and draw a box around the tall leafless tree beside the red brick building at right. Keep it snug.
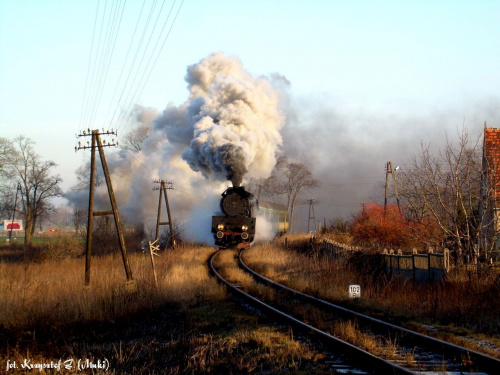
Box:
[400,128,490,262]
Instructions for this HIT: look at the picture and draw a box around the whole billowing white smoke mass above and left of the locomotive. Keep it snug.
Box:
[68,53,285,241]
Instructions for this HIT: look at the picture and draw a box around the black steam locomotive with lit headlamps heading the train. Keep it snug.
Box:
[212,186,255,248]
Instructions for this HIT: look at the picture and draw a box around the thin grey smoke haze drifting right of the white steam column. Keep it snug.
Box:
[282,94,500,231]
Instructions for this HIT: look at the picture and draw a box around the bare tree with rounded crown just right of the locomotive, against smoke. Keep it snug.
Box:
[262,156,320,231]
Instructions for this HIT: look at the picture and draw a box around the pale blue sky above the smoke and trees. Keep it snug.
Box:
[0,0,500,220]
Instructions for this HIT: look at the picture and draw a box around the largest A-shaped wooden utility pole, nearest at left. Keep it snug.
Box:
[75,129,135,290]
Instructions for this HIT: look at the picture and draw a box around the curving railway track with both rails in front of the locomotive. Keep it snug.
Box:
[210,251,500,374]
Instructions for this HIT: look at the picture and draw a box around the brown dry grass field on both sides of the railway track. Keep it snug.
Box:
[0,236,500,374]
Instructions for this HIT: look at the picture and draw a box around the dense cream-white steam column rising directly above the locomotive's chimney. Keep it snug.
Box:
[175,53,284,186]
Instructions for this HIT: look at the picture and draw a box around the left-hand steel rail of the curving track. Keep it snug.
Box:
[209,250,417,375]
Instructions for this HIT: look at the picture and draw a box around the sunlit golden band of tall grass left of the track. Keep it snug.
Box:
[0,247,225,329]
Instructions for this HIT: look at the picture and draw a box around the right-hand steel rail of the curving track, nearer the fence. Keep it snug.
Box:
[238,249,500,374]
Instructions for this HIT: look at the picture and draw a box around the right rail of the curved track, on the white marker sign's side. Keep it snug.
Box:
[239,250,500,374]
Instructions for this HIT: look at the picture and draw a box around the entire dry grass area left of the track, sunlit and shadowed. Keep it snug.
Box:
[0,242,336,374]
